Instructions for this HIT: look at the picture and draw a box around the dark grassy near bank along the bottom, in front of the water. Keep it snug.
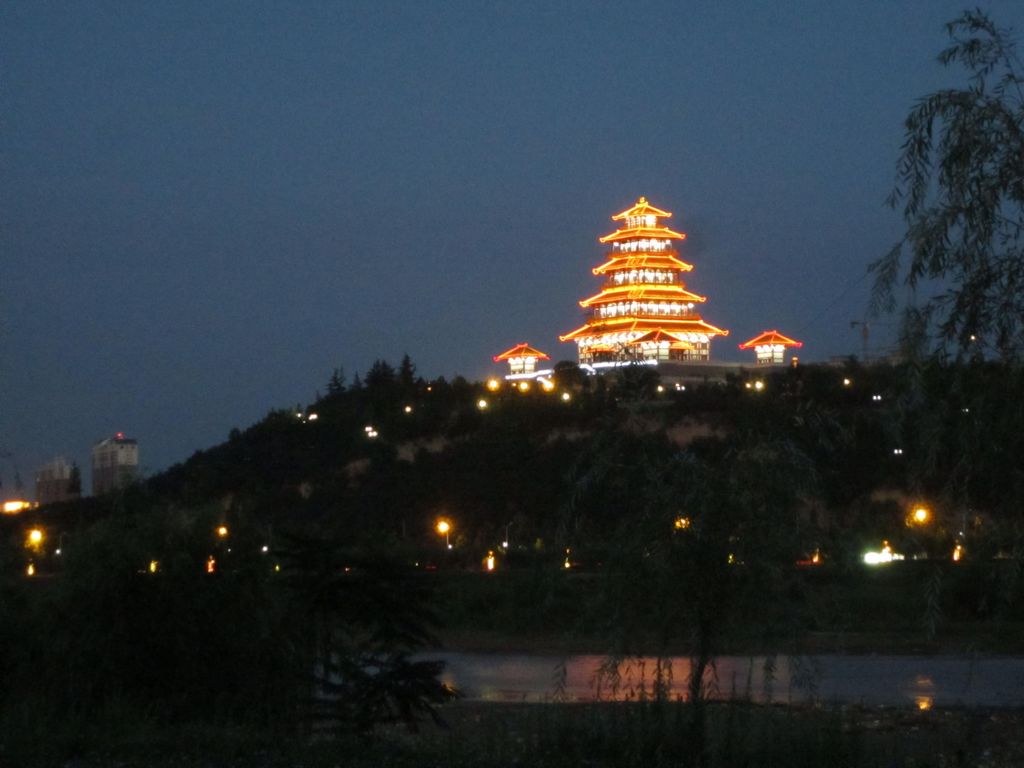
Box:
[8,701,1024,768]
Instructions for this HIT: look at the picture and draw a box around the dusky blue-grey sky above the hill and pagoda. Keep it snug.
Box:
[0,0,1024,487]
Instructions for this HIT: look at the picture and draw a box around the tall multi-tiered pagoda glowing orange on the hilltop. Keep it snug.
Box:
[558,198,729,368]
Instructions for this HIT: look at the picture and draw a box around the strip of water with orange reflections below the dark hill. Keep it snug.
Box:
[430,653,1024,710]
